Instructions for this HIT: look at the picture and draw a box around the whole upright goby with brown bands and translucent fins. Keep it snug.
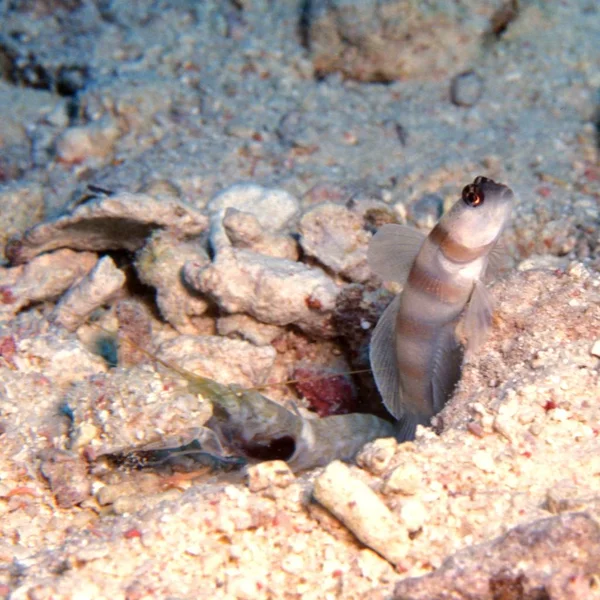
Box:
[369,177,513,439]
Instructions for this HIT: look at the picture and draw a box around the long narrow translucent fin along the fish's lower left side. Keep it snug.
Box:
[369,296,404,419]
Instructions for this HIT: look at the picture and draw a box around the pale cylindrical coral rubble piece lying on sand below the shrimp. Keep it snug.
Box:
[314,461,408,564]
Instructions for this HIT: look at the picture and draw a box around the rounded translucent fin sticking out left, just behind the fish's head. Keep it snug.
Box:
[367,224,426,283]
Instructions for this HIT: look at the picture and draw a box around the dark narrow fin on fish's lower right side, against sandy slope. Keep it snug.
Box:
[431,324,464,414]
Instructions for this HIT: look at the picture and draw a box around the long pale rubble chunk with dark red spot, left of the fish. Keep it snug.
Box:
[184,248,338,337]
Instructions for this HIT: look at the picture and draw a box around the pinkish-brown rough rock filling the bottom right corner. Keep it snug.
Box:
[394,513,600,600]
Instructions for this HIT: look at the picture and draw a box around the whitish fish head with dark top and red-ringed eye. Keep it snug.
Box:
[444,177,514,248]
